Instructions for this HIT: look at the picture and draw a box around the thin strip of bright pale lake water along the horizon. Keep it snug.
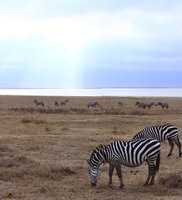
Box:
[0,88,182,97]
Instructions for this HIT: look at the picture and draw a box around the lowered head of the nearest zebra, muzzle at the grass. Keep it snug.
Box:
[87,160,100,186]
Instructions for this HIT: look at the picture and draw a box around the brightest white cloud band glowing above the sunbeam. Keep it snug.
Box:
[0,13,135,49]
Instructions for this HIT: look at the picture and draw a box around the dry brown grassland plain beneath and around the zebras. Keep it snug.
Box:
[0,96,182,200]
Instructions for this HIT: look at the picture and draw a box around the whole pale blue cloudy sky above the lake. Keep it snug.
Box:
[0,0,182,88]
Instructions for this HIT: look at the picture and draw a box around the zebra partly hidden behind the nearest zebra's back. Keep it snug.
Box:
[133,124,182,157]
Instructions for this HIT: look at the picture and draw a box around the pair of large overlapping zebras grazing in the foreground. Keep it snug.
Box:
[87,124,182,188]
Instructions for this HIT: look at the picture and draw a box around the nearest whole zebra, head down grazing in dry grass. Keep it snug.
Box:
[87,138,161,188]
